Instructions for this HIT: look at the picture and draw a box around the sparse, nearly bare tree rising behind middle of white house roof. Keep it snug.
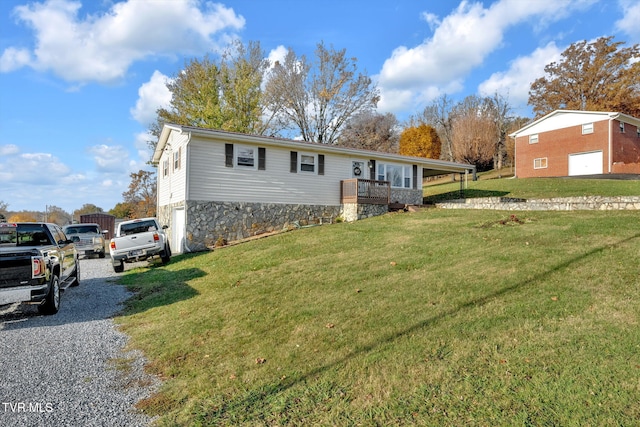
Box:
[265,43,379,144]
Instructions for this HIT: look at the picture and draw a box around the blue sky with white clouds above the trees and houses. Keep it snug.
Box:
[0,0,640,212]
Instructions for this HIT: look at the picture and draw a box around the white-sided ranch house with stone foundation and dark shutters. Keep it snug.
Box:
[152,124,474,253]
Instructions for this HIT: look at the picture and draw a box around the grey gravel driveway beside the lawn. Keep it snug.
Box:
[0,257,158,427]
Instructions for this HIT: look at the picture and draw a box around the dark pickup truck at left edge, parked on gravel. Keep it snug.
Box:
[0,222,80,314]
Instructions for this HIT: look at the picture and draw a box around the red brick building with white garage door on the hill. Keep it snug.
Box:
[509,110,640,178]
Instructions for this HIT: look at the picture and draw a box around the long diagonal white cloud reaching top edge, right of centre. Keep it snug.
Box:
[378,0,594,111]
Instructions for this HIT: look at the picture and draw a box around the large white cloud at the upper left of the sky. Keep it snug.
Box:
[0,0,245,83]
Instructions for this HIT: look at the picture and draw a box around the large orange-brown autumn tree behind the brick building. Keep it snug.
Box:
[529,36,640,117]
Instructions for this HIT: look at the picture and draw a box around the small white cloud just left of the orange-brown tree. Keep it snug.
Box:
[478,42,562,106]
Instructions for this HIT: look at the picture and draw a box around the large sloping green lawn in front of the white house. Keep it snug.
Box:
[117,204,640,426]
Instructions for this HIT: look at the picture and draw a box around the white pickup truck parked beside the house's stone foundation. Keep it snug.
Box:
[109,218,171,273]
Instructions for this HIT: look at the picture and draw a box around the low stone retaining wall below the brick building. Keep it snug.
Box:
[436,196,640,211]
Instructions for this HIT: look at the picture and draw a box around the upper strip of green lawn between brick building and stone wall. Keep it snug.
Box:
[424,173,640,203]
